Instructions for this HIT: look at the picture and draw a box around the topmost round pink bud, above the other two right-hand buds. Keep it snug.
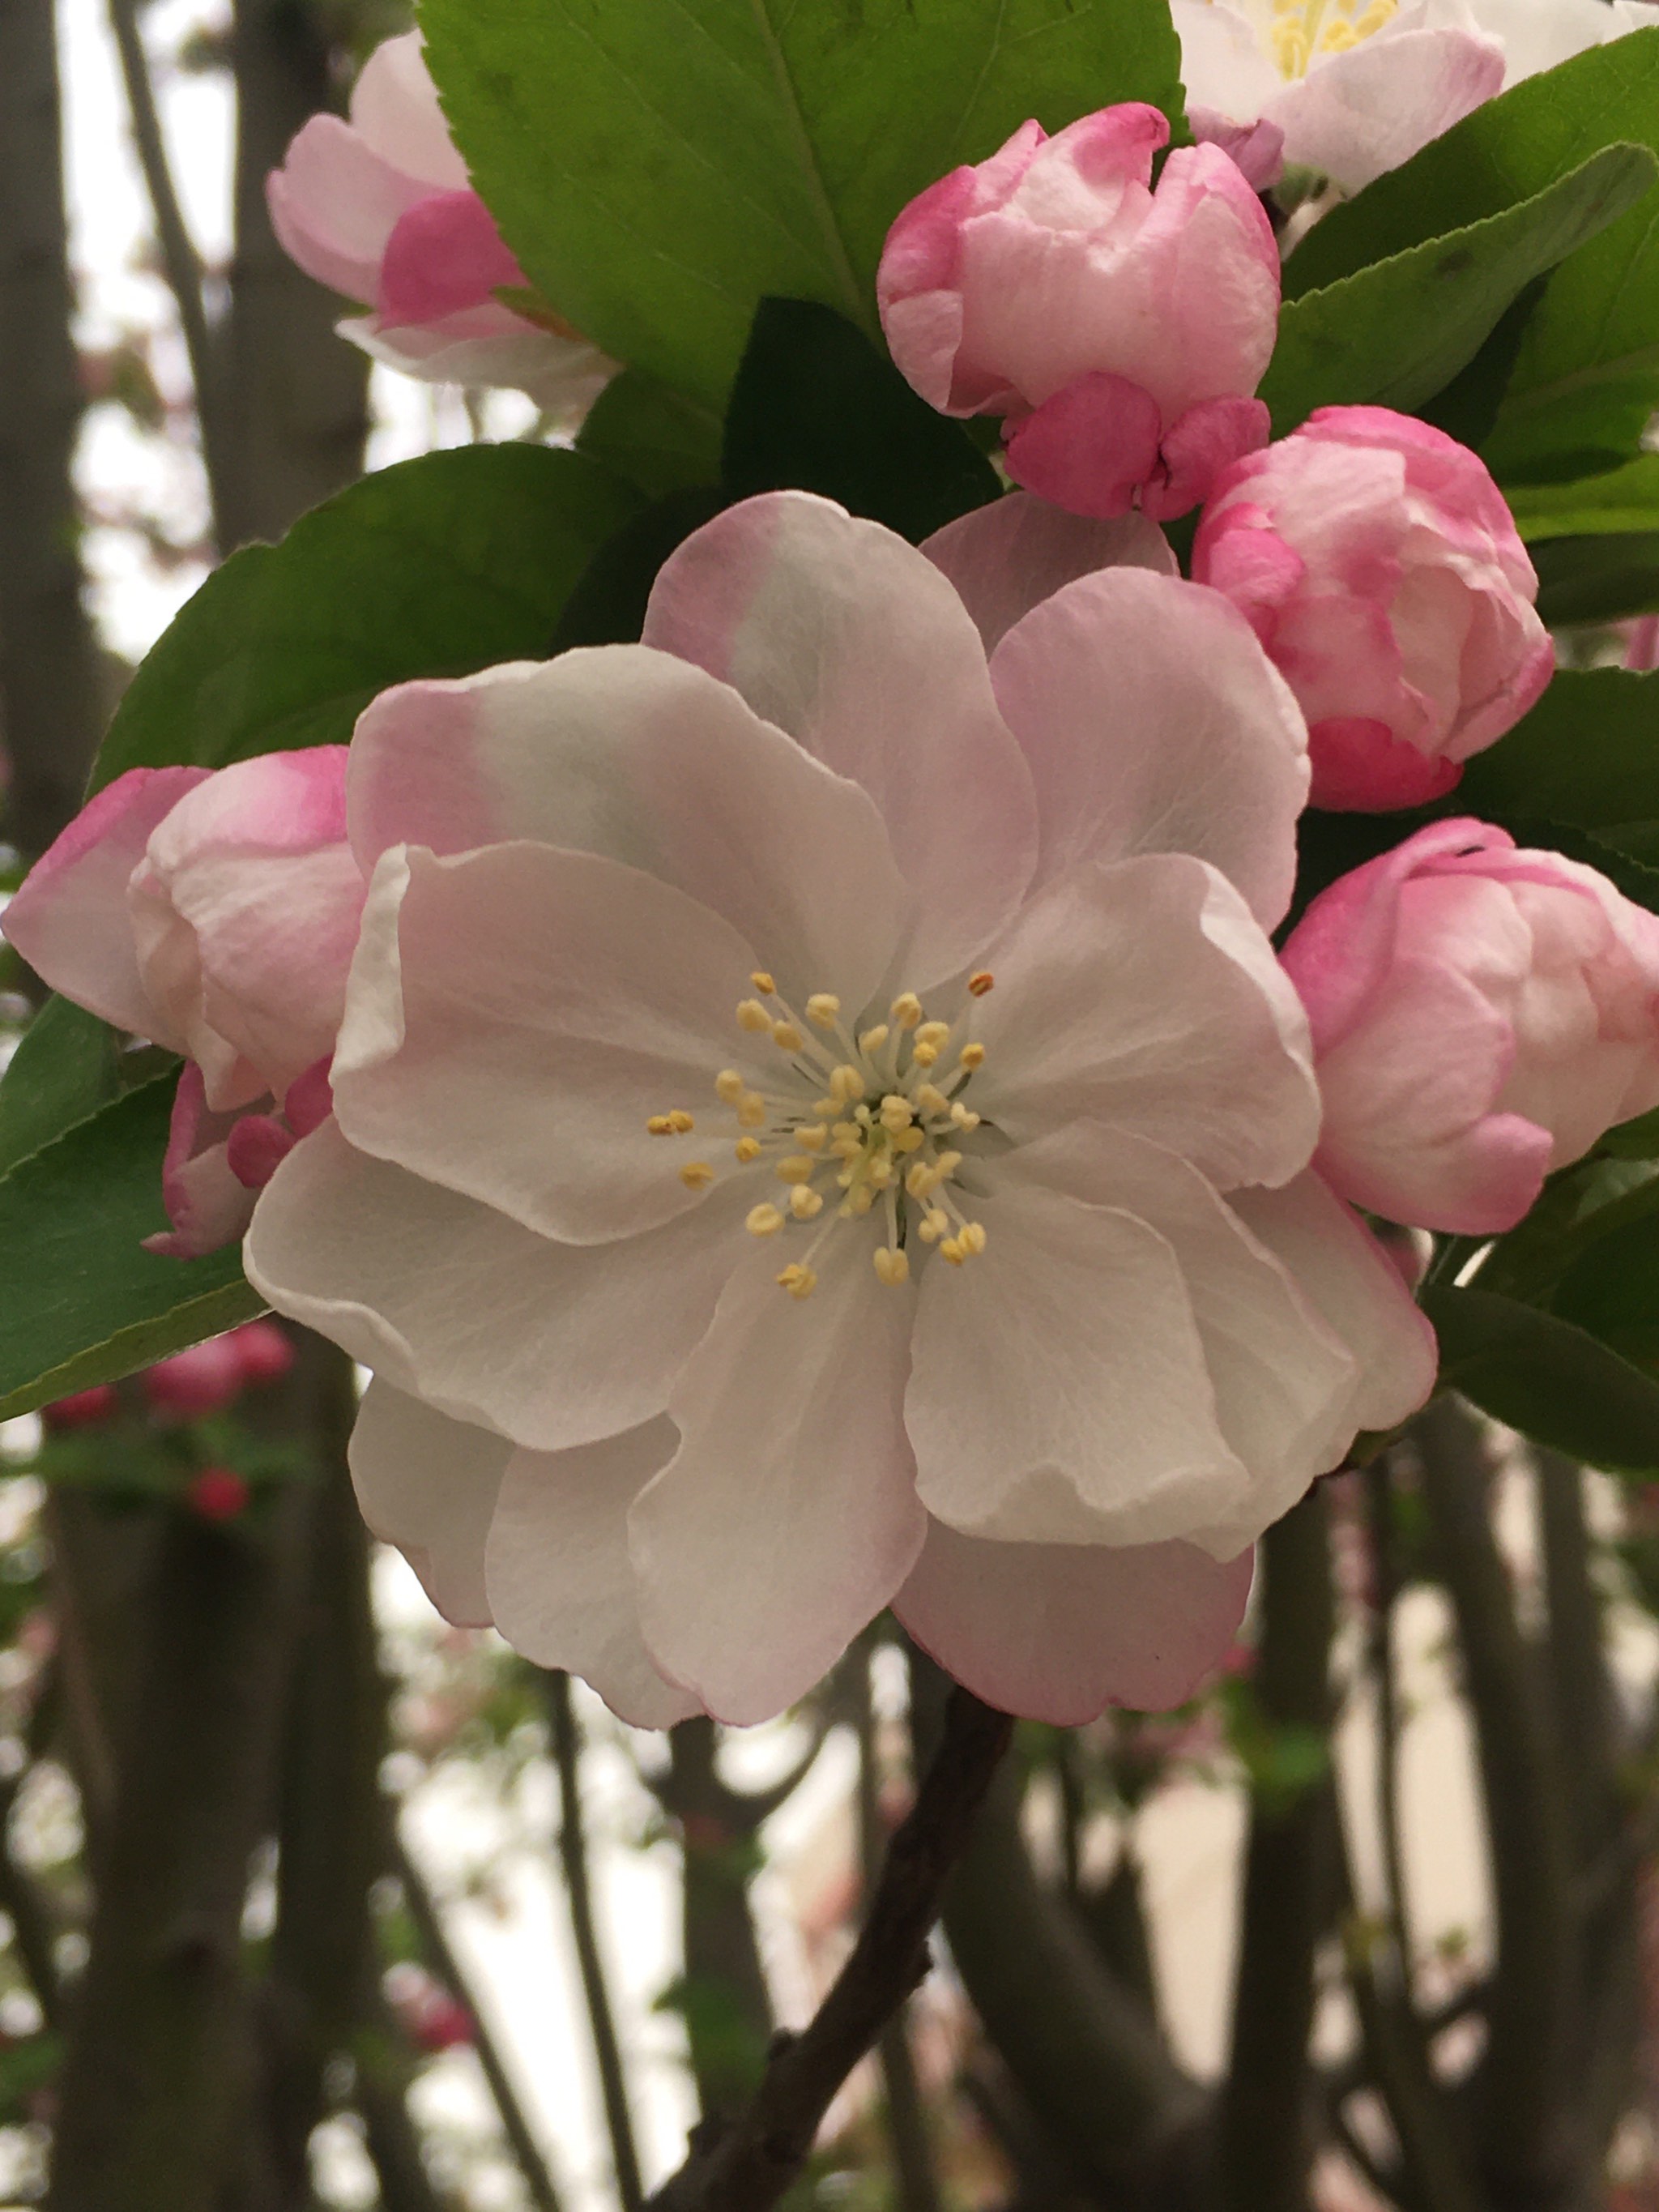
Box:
[876,102,1278,520]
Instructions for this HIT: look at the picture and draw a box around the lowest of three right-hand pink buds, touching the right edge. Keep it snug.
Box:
[1283,821,1659,1236]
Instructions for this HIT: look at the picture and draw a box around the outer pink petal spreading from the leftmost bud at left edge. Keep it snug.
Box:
[0,767,210,1051]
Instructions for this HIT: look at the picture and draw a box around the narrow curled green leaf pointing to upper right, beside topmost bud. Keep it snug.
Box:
[1260,146,1659,436]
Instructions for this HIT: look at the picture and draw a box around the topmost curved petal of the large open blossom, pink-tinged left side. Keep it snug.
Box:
[646,491,1035,991]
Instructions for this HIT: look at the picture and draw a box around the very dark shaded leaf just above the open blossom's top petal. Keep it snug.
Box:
[726,299,1002,542]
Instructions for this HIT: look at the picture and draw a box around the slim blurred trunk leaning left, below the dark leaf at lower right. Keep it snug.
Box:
[1414,1398,1580,2206]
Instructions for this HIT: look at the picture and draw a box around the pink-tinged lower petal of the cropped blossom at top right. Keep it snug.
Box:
[1260,11,1504,193]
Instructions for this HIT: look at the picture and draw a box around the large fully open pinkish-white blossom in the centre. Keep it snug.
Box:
[248,493,1433,1725]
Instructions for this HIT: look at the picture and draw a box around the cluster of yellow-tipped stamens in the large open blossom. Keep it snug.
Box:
[646,969,993,1299]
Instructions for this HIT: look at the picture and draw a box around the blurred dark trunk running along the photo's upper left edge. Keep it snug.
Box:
[0,0,104,854]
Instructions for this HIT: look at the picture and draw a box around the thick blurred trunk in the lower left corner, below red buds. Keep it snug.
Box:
[49,1488,308,2212]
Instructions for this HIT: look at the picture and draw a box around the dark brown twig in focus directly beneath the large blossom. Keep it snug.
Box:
[650,1690,1013,2212]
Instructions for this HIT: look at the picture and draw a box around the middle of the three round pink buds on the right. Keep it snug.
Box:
[1192,407,1555,809]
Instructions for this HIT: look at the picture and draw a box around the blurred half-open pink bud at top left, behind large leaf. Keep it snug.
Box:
[266,31,615,418]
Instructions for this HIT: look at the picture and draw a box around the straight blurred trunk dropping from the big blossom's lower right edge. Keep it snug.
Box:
[1217,1488,1336,2212]
